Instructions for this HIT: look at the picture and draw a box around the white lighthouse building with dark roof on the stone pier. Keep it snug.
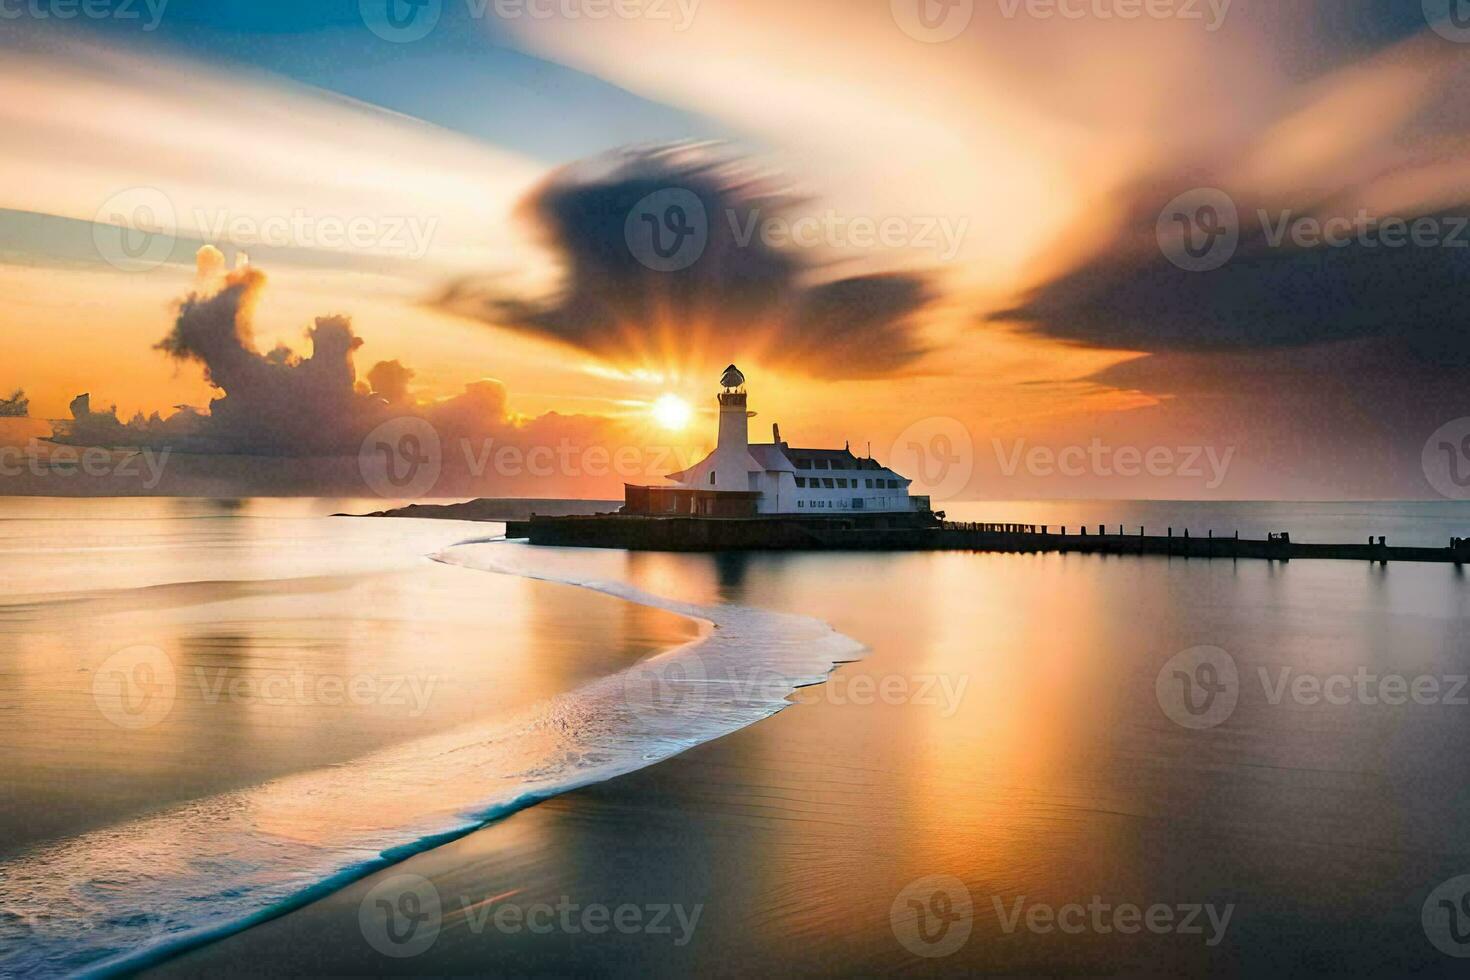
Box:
[623,364,929,517]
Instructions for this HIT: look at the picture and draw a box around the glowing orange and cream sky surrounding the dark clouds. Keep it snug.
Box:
[0,0,1470,499]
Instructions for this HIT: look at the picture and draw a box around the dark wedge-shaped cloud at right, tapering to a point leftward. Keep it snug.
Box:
[991,194,1470,369]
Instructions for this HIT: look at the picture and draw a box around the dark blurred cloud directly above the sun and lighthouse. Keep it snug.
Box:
[441,147,932,378]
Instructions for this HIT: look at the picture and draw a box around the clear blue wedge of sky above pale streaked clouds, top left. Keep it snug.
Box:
[44,0,736,163]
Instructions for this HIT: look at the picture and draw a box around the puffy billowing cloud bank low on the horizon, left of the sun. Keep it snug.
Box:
[38,247,678,497]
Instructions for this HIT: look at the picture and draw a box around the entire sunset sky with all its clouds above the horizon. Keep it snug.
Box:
[0,0,1470,500]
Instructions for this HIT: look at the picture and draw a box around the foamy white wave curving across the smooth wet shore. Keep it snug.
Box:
[0,541,863,976]
